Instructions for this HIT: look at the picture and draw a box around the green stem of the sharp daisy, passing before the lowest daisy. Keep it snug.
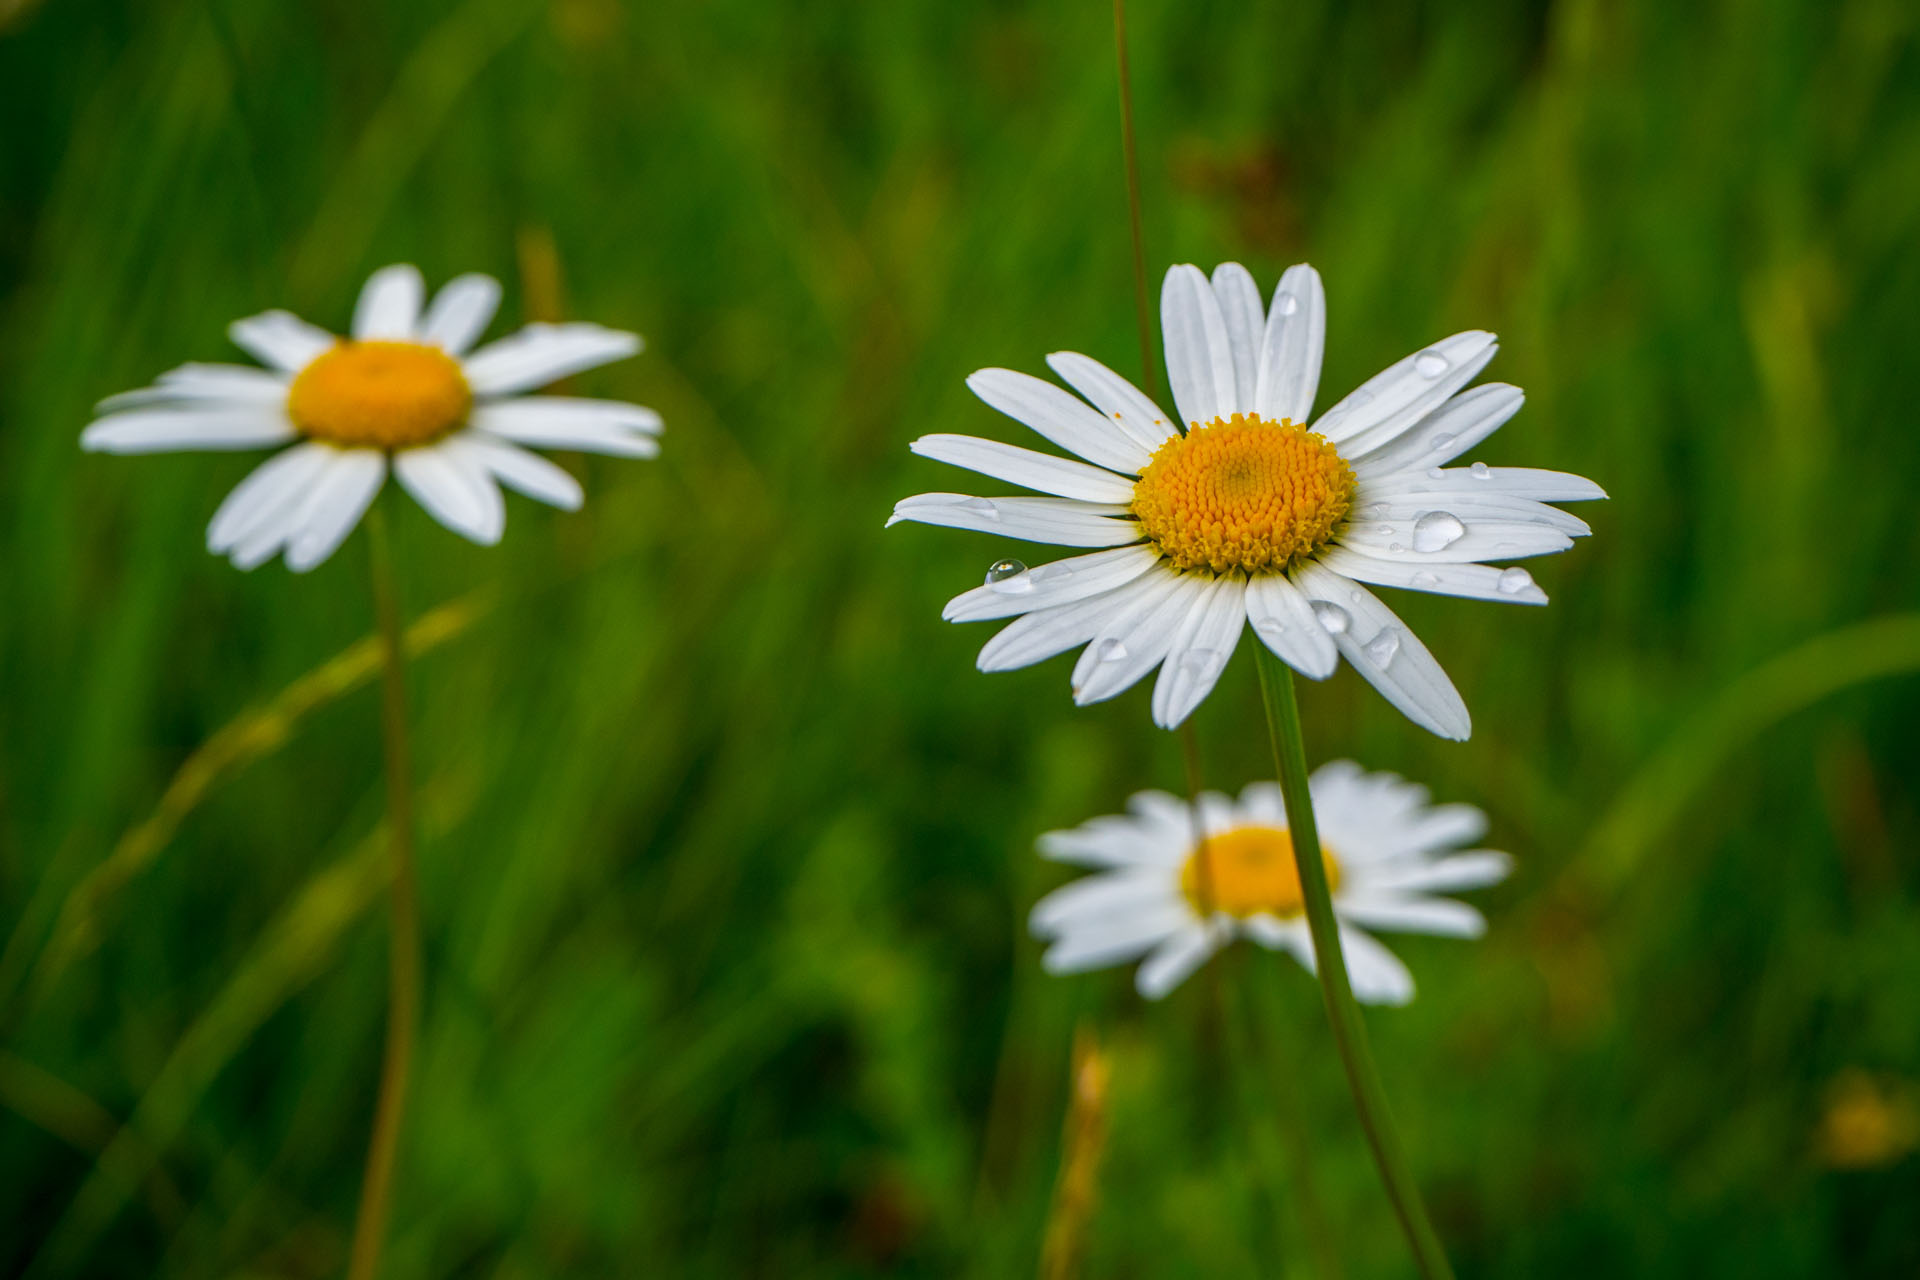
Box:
[1254,645,1453,1280]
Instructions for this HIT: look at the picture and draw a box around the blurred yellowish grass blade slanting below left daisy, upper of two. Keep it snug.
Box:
[0,587,497,1004]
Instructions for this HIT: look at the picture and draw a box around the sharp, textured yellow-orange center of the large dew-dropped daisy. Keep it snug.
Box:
[1133,413,1354,574]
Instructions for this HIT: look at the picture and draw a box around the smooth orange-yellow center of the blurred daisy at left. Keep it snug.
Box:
[286,342,474,449]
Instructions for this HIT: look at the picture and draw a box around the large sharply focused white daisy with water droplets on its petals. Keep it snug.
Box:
[889,263,1605,739]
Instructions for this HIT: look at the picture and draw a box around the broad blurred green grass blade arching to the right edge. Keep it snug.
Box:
[1563,614,1920,898]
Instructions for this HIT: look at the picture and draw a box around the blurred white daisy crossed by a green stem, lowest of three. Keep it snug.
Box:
[1029,760,1511,1004]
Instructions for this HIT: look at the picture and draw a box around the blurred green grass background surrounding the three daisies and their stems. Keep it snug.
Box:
[0,0,1920,1278]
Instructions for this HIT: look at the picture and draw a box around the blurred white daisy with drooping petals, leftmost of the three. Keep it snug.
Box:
[81,265,660,572]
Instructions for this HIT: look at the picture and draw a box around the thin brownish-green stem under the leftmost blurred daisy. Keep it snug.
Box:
[348,507,420,1280]
